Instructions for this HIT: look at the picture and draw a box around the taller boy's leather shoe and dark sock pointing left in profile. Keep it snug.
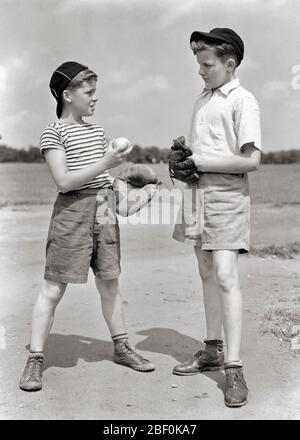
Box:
[173,339,224,376]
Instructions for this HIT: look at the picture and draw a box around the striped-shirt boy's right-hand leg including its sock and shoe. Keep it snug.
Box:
[95,277,155,372]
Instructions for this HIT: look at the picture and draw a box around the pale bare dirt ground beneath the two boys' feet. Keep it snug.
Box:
[0,206,300,420]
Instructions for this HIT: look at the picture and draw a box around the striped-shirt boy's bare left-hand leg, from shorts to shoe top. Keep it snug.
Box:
[30,280,67,352]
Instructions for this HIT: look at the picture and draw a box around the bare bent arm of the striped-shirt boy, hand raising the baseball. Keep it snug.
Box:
[44,147,130,193]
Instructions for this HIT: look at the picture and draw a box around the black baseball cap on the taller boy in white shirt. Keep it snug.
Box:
[190,28,244,65]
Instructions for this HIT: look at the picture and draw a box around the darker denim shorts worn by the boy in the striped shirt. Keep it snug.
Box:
[44,188,121,283]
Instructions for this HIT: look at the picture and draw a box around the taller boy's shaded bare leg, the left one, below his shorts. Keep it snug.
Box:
[194,247,222,340]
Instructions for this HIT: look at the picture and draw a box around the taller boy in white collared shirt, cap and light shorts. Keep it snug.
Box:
[173,28,261,407]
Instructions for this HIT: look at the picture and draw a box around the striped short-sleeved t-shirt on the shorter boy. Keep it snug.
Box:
[40,122,113,189]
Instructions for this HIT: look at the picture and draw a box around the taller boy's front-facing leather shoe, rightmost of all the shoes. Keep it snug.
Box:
[224,364,248,407]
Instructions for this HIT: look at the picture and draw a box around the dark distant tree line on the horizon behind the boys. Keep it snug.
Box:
[0,144,300,164]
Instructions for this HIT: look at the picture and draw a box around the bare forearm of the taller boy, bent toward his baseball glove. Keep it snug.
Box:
[190,142,261,174]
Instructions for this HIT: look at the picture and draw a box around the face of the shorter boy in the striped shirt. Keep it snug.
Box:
[69,79,97,116]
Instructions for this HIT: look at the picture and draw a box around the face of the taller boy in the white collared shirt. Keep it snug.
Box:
[196,49,233,89]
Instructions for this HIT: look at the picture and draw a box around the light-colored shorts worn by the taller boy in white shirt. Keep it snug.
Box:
[173,173,250,253]
